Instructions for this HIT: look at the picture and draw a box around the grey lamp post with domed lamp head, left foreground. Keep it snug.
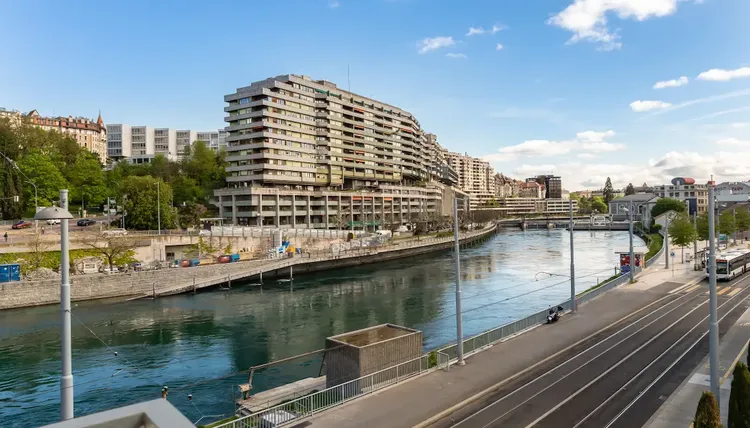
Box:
[34,189,73,420]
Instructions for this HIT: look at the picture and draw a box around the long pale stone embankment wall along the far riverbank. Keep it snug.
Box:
[0,226,497,309]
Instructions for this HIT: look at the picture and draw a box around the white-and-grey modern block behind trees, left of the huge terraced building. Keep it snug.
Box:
[107,123,227,164]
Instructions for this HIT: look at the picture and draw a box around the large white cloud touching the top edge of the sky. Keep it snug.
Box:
[547,0,679,51]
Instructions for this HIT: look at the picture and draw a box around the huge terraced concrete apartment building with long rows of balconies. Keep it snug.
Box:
[214,74,466,228]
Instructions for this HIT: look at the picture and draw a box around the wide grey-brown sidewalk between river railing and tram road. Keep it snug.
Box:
[309,262,703,428]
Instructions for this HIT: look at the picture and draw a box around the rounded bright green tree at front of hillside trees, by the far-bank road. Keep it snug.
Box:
[118,176,174,230]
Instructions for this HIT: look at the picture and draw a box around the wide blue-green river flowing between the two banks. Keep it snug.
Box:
[0,230,643,427]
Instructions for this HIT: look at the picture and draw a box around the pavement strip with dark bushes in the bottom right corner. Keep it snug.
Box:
[644,309,750,428]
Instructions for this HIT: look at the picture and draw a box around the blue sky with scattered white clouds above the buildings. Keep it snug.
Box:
[0,0,750,189]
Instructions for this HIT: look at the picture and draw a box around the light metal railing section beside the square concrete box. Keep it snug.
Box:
[214,352,450,428]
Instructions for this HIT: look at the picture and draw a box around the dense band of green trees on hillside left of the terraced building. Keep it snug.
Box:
[0,118,226,229]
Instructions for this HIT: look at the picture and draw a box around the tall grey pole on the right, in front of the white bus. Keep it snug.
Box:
[708,185,721,409]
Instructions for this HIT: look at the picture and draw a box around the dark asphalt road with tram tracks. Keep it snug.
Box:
[433,278,750,428]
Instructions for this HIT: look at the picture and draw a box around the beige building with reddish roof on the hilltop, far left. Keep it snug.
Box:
[0,108,107,163]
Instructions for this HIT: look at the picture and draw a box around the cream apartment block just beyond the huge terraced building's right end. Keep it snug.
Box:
[444,152,496,208]
